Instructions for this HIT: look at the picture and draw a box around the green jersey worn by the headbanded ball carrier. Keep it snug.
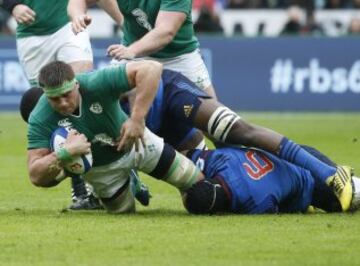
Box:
[28,65,130,166]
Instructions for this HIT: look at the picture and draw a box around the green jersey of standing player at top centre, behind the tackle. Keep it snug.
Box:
[117,0,199,58]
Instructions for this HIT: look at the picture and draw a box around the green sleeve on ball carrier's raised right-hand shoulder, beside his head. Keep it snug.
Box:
[76,64,131,100]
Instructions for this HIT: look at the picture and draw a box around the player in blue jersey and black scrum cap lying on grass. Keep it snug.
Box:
[184,147,360,214]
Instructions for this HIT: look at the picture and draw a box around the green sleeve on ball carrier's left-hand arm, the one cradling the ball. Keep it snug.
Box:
[28,116,51,150]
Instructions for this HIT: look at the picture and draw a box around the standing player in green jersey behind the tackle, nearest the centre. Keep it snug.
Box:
[68,0,216,98]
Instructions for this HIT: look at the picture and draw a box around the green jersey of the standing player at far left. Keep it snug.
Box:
[16,0,69,38]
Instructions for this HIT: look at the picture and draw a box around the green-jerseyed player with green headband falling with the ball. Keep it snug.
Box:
[28,61,202,213]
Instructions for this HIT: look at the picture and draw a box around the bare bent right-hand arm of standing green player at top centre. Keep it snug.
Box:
[107,10,186,59]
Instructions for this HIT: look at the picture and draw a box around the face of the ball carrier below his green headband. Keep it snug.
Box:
[48,82,79,115]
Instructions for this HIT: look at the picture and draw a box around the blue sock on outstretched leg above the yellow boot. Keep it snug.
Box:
[279,137,336,182]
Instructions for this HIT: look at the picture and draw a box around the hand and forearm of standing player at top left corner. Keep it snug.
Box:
[1,0,36,24]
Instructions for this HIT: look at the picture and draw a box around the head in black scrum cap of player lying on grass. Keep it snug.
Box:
[185,179,230,214]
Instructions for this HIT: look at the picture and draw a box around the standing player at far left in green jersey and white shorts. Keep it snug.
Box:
[3,0,99,209]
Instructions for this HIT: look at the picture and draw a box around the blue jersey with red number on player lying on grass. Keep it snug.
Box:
[190,148,314,214]
